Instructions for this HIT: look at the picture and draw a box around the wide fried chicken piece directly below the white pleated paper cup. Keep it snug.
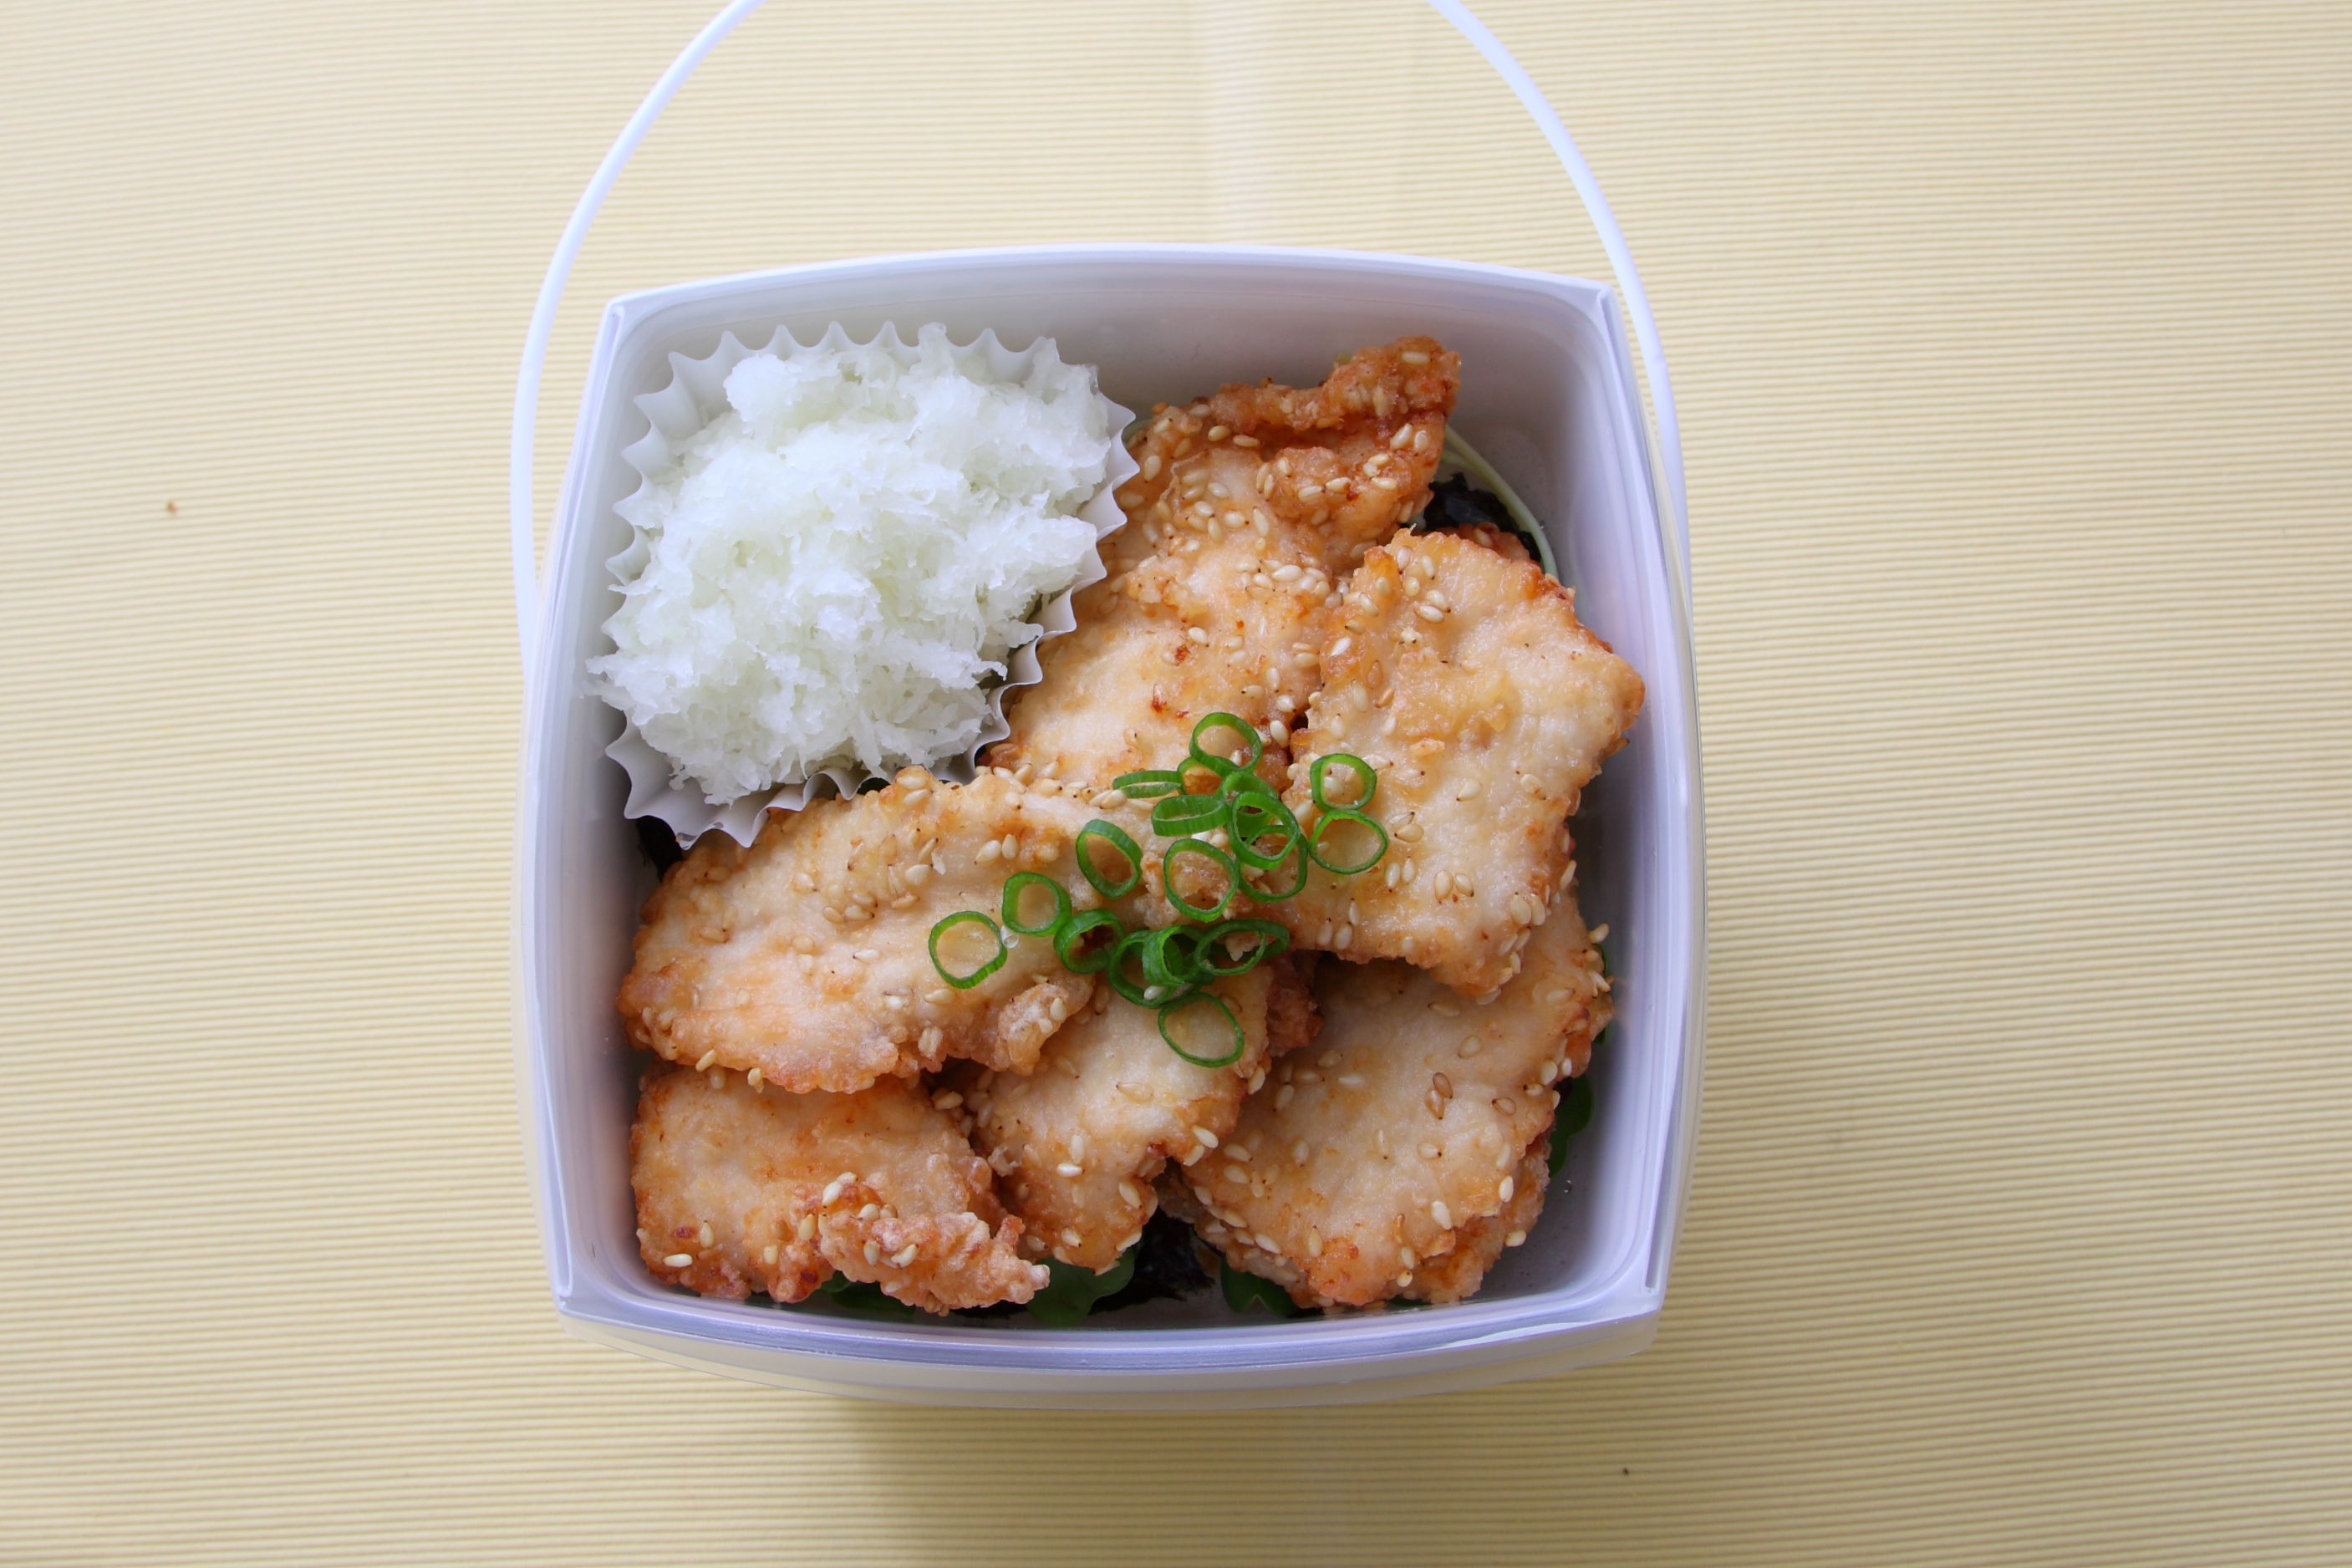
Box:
[621,769,1162,1093]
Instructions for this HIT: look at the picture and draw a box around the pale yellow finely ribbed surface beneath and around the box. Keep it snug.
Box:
[0,0,2352,1565]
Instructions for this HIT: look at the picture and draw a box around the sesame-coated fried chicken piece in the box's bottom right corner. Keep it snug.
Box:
[1162,896,1609,1307]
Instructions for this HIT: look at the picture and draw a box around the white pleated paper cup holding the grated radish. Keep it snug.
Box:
[604,322,1138,844]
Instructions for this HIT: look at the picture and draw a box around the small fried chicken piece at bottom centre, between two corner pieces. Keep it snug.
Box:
[957,960,1312,1274]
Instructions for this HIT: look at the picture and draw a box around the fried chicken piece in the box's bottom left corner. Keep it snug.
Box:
[628,1070,1046,1311]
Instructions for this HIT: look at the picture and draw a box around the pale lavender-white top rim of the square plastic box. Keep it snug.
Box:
[512,242,1705,1403]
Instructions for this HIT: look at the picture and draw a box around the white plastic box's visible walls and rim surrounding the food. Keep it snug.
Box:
[517,245,1703,1408]
